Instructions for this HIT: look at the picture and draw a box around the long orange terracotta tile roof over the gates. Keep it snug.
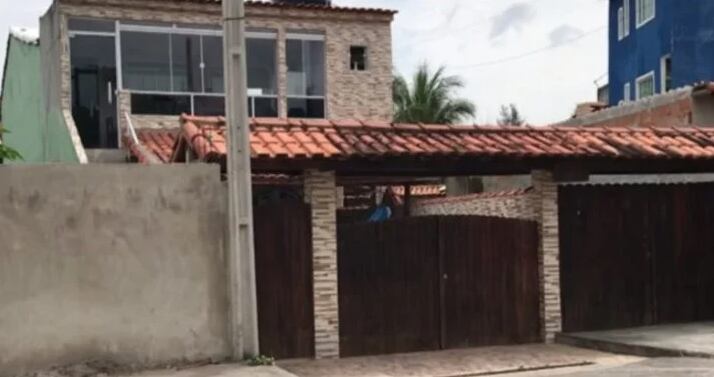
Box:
[130,116,714,162]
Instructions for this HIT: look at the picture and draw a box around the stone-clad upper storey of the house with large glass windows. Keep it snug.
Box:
[2,0,395,162]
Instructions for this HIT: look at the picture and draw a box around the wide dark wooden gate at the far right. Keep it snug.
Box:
[560,184,714,332]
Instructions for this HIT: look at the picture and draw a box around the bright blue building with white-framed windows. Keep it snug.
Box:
[609,0,714,105]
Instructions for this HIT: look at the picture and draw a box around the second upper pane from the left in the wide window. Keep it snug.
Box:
[171,34,203,92]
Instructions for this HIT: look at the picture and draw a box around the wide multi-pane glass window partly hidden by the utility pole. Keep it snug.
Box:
[121,24,278,117]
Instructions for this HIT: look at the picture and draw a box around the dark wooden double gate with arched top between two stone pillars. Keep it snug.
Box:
[338,216,540,356]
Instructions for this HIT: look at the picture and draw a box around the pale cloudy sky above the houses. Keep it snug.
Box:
[0,0,608,125]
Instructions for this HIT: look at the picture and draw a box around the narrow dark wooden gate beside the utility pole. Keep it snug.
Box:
[254,202,315,359]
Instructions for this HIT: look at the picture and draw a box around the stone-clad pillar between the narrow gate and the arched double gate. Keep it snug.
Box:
[305,170,340,359]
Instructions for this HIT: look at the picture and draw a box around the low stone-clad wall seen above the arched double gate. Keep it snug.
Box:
[412,190,538,220]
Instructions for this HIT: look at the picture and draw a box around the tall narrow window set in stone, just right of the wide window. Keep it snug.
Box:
[286,35,325,118]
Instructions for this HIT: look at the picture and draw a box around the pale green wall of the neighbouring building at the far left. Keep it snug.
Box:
[0,36,44,163]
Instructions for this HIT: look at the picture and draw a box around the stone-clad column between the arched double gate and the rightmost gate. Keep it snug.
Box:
[532,171,563,343]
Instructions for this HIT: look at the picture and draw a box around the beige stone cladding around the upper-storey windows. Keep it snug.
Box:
[59,0,393,121]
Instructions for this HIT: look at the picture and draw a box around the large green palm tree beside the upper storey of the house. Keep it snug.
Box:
[394,63,476,124]
